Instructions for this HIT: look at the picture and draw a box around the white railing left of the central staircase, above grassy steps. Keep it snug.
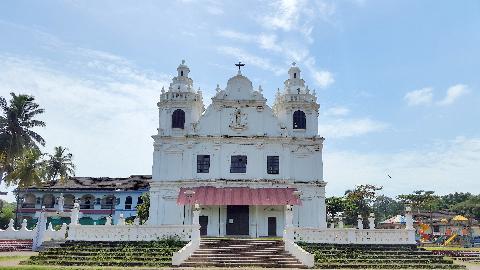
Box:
[67,223,199,241]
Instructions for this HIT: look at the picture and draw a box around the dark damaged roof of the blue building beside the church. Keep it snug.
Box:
[20,175,152,190]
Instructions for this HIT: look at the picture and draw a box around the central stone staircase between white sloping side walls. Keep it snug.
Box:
[181,238,306,268]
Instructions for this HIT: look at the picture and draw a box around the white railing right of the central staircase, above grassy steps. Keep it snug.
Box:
[286,227,415,245]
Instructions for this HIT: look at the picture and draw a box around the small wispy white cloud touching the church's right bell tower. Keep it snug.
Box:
[318,118,388,138]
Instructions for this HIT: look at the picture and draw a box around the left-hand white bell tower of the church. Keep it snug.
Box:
[157,60,205,136]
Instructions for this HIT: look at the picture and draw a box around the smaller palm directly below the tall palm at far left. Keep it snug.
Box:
[4,148,45,188]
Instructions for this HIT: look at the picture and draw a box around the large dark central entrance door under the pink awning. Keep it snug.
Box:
[227,205,250,235]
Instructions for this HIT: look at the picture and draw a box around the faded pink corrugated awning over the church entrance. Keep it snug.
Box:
[177,187,302,205]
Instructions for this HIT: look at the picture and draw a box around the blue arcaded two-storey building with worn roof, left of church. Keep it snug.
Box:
[17,175,151,227]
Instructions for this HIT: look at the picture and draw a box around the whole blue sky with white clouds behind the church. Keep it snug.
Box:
[0,0,480,200]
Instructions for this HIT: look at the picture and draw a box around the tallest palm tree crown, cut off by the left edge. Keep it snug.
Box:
[0,93,45,178]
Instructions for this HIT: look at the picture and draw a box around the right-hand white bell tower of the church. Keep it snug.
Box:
[273,62,320,137]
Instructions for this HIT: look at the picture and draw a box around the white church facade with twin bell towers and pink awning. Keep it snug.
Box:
[148,61,326,237]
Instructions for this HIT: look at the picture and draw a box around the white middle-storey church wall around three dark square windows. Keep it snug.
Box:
[153,138,323,181]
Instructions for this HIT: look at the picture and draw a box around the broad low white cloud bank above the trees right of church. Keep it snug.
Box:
[324,137,480,196]
